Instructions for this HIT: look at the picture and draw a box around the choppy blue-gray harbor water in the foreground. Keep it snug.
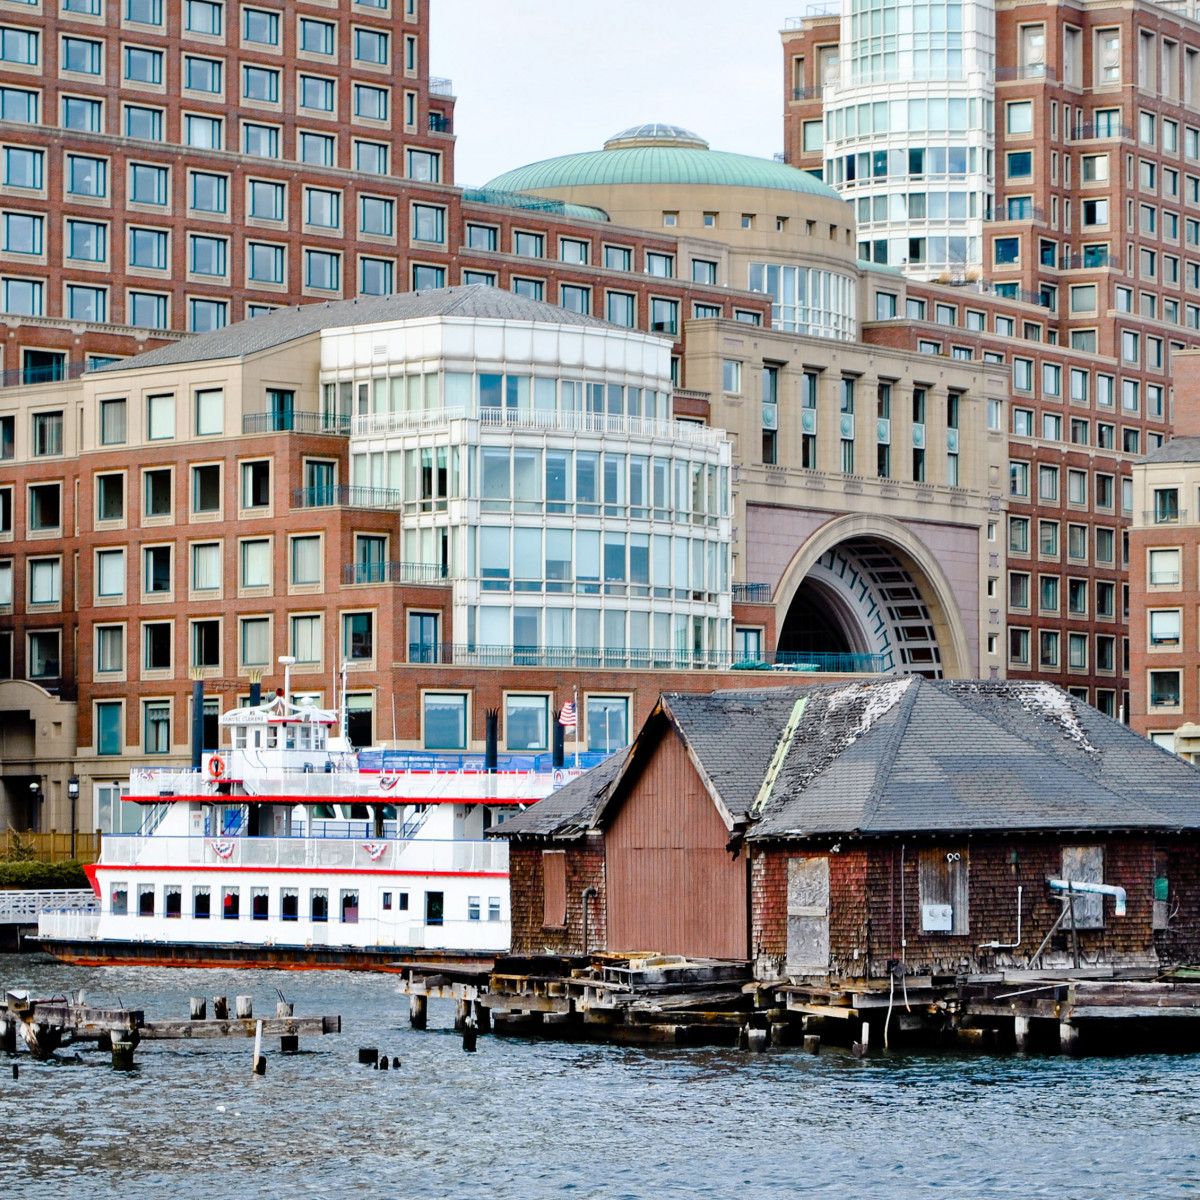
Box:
[0,955,1200,1200]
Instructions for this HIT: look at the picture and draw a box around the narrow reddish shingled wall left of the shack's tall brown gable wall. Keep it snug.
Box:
[509,838,608,955]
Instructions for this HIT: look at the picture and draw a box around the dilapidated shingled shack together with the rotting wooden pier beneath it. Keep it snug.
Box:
[446,677,1200,1050]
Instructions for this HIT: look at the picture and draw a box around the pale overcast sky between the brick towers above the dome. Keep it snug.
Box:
[430,0,808,186]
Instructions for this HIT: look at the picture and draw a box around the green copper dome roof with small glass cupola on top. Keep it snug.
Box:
[484,124,840,199]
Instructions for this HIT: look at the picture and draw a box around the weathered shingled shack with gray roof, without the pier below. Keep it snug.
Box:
[498,678,1200,979]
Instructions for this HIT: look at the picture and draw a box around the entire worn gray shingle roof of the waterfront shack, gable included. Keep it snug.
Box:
[494,677,1200,840]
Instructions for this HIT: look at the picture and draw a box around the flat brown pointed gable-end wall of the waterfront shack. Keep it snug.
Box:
[605,731,750,959]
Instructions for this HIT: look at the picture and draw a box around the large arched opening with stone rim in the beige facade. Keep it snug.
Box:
[775,515,976,679]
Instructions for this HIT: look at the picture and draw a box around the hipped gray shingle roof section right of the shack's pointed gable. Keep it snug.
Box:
[750,678,1200,838]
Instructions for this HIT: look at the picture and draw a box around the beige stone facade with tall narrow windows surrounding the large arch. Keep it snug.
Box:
[686,322,1007,677]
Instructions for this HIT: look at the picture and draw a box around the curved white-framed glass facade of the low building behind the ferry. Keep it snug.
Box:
[333,307,732,667]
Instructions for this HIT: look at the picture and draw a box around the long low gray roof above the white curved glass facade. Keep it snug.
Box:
[94,283,629,372]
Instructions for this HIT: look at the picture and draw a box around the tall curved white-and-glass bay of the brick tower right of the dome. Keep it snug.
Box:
[824,0,995,280]
